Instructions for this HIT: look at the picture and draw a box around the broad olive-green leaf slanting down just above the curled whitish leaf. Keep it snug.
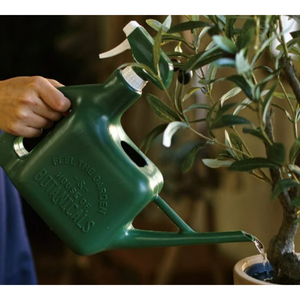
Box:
[146,94,180,122]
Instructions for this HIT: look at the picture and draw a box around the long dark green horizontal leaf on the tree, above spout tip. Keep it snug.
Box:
[230,157,280,172]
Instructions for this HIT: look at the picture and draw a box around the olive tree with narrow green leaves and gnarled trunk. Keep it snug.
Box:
[137,15,300,284]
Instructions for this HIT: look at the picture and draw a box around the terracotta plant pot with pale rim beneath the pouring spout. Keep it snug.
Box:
[233,254,273,285]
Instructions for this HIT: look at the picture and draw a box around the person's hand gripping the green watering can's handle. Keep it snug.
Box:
[0,76,71,137]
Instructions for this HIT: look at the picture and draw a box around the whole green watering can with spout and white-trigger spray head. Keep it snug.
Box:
[0,21,254,255]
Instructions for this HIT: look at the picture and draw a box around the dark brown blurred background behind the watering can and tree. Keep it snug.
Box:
[0,15,289,285]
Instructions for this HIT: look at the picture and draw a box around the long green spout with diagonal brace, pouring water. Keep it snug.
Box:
[111,195,255,249]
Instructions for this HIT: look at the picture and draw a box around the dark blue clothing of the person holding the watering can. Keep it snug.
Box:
[0,131,37,285]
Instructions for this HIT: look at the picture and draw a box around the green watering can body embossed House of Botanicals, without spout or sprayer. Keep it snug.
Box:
[0,72,163,254]
